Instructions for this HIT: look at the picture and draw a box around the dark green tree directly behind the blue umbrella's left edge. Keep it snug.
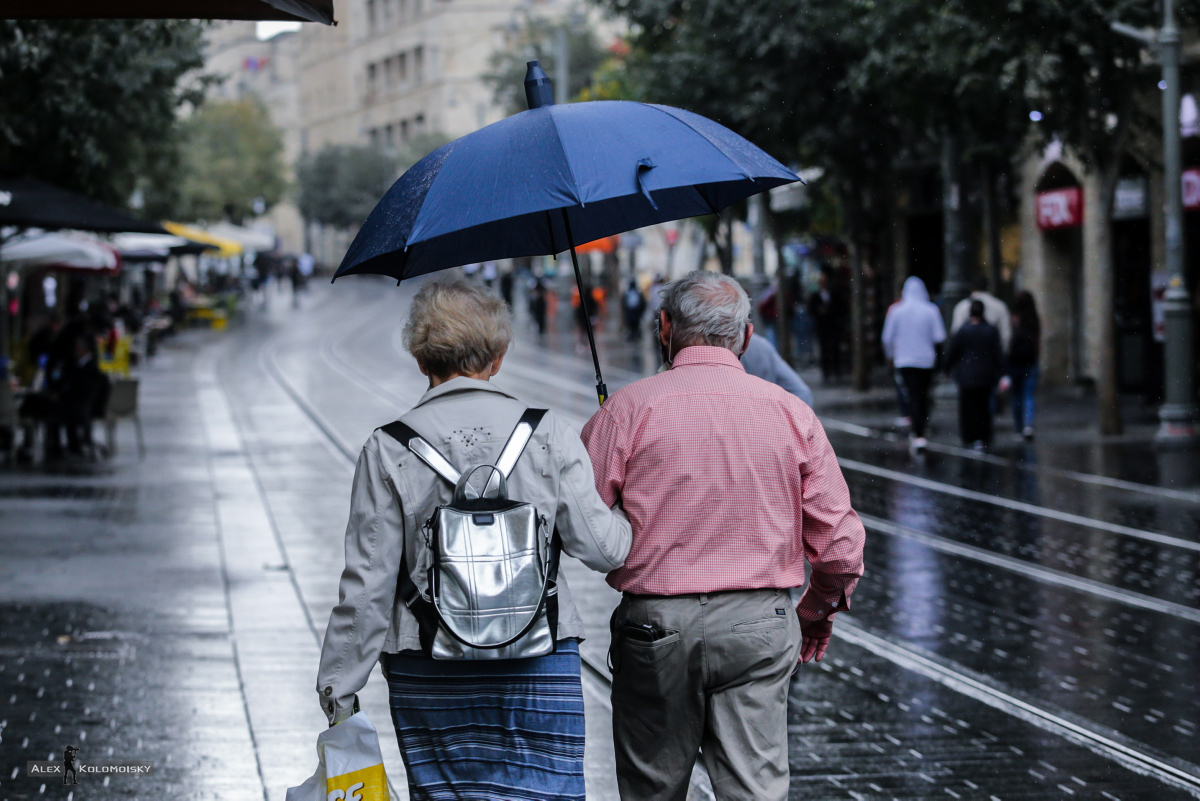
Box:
[296,133,446,229]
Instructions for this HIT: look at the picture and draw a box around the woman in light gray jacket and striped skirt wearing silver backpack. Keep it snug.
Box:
[317,279,630,801]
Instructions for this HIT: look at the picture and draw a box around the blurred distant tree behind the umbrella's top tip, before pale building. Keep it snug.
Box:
[484,14,608,114]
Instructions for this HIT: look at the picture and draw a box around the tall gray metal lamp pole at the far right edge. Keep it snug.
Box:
[1158,0,1196,438]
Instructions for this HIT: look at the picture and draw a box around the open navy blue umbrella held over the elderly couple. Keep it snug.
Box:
[334,61,799,403]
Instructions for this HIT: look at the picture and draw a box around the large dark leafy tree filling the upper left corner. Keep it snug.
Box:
[0,19,206,205]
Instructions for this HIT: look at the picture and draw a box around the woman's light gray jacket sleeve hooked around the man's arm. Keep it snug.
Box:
[554,417,632,573]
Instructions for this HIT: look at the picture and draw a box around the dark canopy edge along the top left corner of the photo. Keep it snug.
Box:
[0,0,336,25]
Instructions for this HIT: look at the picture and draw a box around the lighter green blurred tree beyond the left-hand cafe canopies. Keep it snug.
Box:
[179,100,287,223]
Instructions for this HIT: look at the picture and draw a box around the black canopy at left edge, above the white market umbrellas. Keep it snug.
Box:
[0,177,167,234]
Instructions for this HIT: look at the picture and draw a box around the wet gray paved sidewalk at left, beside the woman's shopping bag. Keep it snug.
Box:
[0,331,386,801]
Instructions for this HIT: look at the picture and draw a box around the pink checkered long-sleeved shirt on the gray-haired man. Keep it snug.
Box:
[583,345,866,621]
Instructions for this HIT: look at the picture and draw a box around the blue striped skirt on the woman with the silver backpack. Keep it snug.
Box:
[384,640,584,801]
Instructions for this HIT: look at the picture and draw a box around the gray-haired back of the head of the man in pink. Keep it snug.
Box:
[659,270,750,356]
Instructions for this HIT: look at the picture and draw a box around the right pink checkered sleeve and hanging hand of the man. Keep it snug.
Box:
[797,417,866,622]
